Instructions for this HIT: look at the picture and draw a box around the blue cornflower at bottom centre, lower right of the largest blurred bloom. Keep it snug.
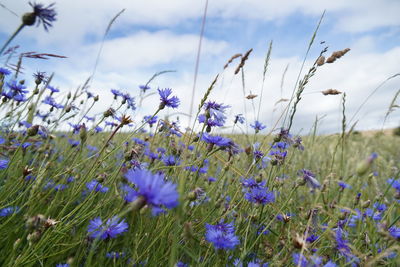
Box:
[206,223,240,250]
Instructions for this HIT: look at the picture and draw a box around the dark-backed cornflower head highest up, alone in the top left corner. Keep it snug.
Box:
[22,2,57,31]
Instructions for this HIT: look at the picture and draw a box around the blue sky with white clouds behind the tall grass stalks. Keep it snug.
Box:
[0,0,400,134]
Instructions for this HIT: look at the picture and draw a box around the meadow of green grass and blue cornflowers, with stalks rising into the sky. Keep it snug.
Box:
[0,4,400,267]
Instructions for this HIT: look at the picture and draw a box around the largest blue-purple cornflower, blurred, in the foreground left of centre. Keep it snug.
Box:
[125,169,179,215]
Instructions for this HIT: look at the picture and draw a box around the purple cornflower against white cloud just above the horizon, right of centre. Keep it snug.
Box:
[199,101,229,129]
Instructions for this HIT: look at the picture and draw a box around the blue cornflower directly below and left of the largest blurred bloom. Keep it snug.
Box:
[88,216,128,240]
